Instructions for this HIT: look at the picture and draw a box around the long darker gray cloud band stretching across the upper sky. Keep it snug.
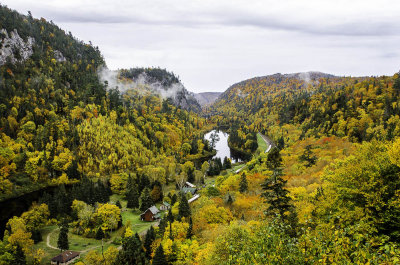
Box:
[29,8,400,36]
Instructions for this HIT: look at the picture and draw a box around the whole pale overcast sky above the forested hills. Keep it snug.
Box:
[0,0,400,92]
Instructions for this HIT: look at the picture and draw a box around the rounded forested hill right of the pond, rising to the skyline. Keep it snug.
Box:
[211,72,400,147]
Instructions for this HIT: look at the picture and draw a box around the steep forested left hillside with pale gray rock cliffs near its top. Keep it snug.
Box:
[0,6,208,199]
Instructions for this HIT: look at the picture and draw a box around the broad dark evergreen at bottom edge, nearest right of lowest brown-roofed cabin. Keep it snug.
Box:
[114,233,149,265]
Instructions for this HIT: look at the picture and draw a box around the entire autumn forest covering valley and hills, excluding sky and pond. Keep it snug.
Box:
[0,3,400,265]
